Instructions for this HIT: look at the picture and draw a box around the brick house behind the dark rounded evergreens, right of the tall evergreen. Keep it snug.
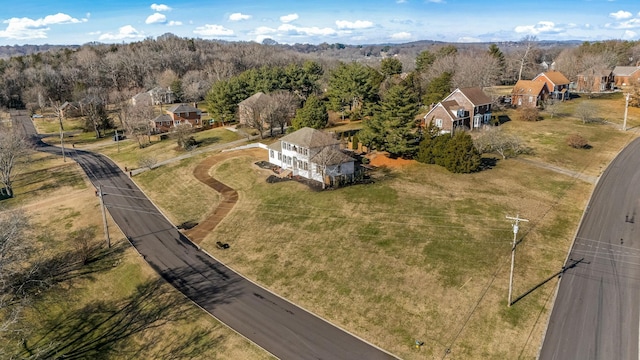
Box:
[424,87,492,133]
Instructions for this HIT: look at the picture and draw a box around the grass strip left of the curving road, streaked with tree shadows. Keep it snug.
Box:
[0,139,270,359]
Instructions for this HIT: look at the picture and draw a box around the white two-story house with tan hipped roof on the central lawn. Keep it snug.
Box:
[268,127,355,184]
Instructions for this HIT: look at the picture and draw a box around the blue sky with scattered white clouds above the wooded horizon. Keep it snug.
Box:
[0,0,640,45]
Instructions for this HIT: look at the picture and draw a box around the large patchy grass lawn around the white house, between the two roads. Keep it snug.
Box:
[130,96,640,359]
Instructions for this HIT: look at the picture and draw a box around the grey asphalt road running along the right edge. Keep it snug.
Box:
[539,139,640,360]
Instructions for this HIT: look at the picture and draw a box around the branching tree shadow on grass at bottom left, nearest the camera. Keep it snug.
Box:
[18,280,220,359]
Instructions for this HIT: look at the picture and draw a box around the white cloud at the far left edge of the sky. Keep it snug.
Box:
[0,13,88,39]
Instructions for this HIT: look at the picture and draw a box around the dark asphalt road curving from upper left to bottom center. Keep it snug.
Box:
[14,114,396,360]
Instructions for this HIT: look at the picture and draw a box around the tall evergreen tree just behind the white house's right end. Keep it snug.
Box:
[359,85,418,157]
